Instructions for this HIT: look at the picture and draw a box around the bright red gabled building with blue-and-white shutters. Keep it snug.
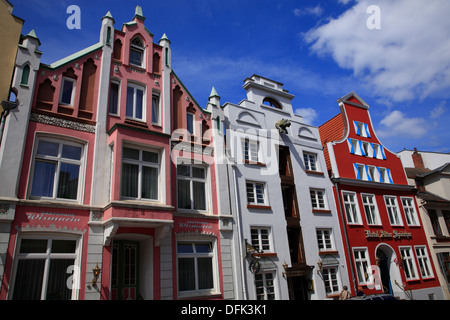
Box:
[319,92,444,299]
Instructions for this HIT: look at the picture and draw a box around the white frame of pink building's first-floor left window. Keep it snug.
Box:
[28,136,87,203]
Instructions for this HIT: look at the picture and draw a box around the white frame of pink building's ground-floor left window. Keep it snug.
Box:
[8,233,82,300]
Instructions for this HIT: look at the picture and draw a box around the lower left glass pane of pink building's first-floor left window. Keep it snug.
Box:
[31,160,56,198]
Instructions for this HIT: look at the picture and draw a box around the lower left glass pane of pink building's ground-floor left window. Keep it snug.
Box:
[13,259,45,300]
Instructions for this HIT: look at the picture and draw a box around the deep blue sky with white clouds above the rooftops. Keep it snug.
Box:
[11,0,450,152]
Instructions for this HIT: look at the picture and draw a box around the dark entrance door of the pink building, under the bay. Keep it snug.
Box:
[111,241,139,300]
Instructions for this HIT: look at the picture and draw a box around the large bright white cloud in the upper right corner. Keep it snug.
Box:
[304,0,450,101]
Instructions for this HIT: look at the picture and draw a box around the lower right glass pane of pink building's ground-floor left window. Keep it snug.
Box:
[46,259,75,300]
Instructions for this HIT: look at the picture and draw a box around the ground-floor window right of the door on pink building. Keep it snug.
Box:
[177,241,216,294]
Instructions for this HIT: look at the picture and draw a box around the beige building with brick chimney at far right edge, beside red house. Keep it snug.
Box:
[398,149,450,300]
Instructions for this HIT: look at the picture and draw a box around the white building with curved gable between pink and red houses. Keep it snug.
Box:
[220,75,349,300]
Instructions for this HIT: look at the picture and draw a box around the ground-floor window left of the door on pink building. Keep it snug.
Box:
[13,237,79,300]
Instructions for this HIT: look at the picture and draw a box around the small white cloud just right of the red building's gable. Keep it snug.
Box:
[377,110,428,139]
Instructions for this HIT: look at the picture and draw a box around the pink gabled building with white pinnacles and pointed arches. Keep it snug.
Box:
[0,6,234,300]
